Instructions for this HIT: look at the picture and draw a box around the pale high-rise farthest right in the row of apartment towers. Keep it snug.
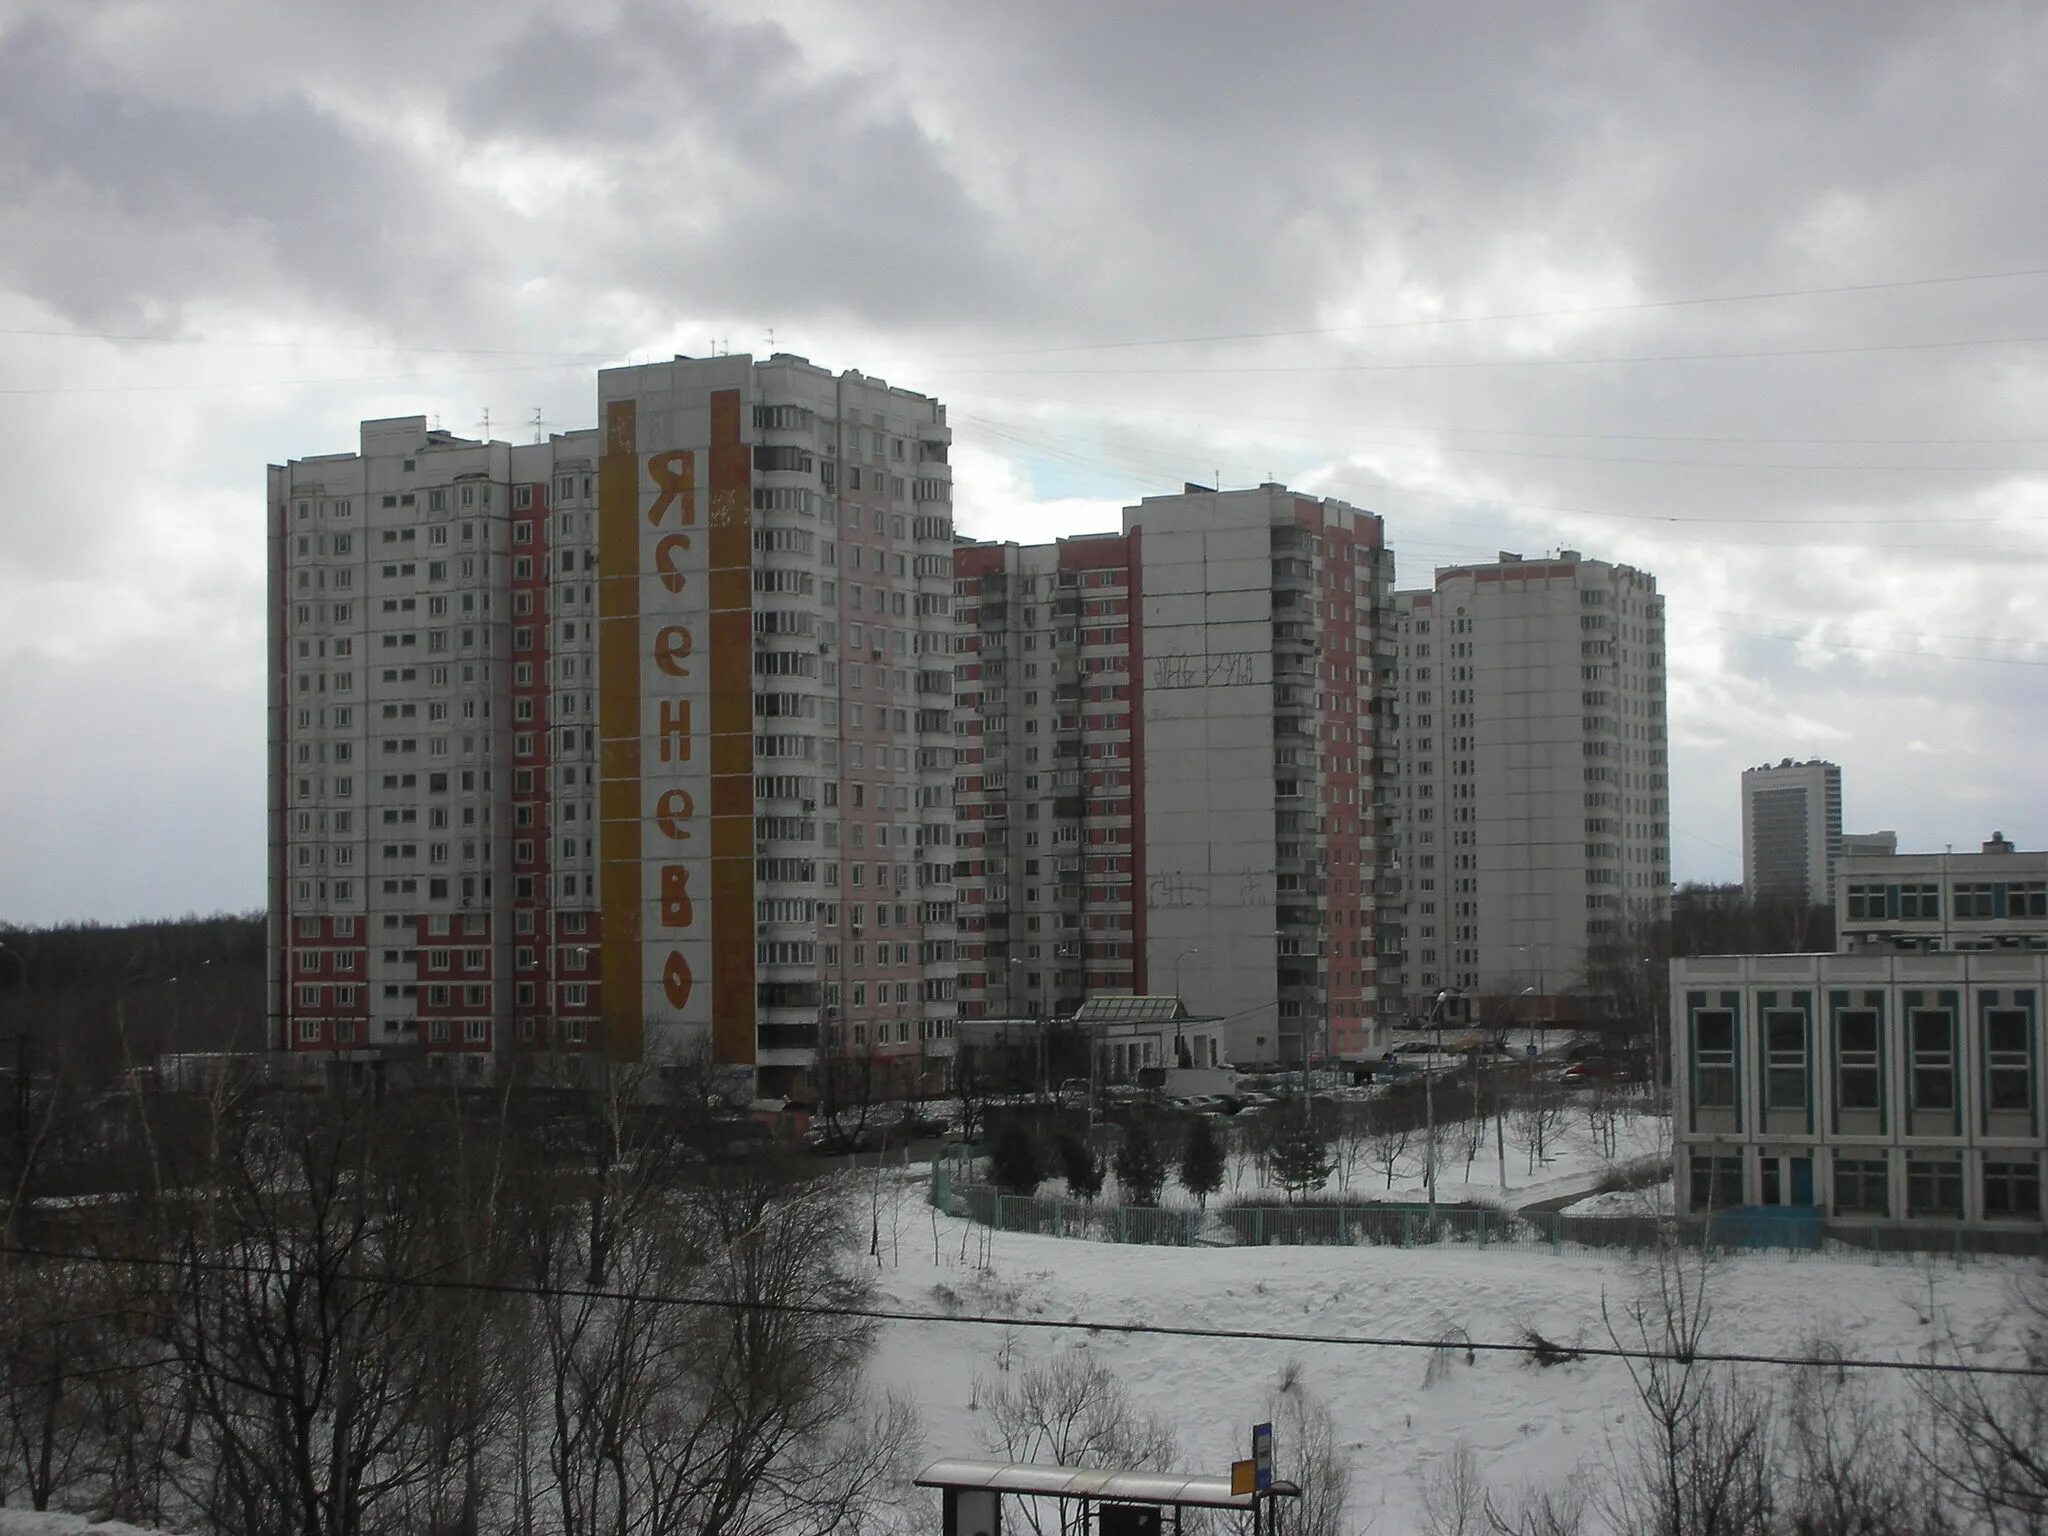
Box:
[1395,549,1671,1014]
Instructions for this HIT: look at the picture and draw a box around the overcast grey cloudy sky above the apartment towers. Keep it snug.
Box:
[0,0,2048,922]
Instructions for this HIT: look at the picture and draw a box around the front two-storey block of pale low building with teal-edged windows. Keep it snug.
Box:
[1671,958,2048,1229]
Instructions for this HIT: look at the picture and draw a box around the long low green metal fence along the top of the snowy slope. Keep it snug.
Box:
[930,1155,2048,1264]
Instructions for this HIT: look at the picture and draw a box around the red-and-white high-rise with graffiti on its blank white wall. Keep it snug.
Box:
[954,485,1401,1065]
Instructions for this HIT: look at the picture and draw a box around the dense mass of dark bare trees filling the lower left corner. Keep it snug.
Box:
[0,1067,915,1536]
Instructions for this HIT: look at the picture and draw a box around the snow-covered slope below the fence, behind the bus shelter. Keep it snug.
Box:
[874,1169,2017,1532]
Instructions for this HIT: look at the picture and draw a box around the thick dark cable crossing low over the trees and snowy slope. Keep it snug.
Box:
[0,1243,2048,1378]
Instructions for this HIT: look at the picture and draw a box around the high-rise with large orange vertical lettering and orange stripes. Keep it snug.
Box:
[268,354,954,1092]
